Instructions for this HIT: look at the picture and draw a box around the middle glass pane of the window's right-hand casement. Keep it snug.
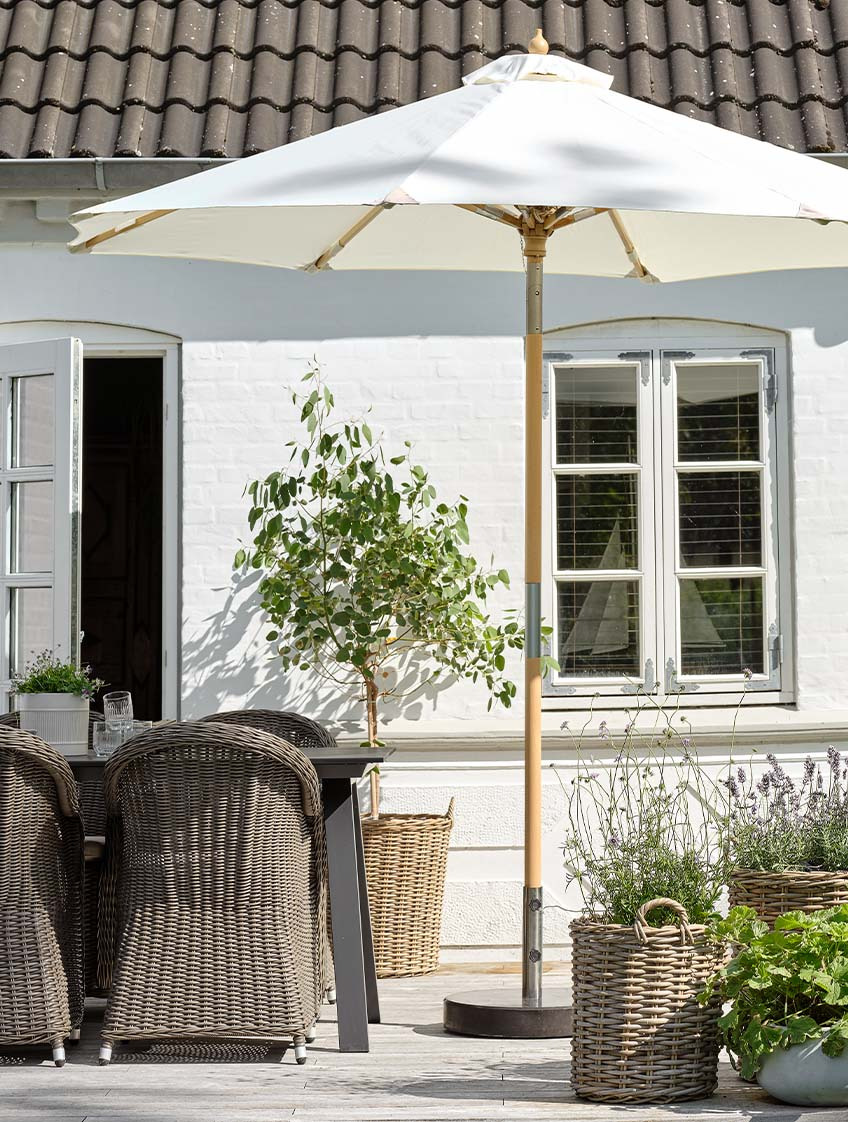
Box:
[678,471,763,569]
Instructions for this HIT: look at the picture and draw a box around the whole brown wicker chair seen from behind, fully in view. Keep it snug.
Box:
[100,723,326,1064]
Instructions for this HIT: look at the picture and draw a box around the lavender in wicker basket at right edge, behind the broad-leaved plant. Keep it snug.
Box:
[725,745,848,923]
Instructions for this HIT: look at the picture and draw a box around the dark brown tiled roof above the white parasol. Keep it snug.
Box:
[0,0,848,158]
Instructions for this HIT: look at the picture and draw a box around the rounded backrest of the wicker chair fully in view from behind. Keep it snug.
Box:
[105,721,325,908]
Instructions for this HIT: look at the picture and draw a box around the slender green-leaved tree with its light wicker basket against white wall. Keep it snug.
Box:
[236,367,524,976]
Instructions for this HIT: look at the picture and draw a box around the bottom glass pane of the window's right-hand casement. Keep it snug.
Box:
[680,577,764,674]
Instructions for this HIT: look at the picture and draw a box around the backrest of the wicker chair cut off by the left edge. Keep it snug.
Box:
[0,725,83,901]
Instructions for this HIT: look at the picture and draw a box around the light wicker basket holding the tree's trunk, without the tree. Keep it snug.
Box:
[362,799,453,978]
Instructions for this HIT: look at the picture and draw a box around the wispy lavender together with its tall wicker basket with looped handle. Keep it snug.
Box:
[564,699,727,1103]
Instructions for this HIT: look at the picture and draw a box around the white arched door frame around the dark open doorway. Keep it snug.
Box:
[0,320,182,720]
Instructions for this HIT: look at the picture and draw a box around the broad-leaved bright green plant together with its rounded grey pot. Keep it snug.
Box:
[701,904,848,1106]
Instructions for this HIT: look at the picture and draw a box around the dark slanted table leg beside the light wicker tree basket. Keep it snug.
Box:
[322,779,368,1052]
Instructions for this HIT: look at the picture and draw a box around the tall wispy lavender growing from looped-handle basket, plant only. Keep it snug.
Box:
[564,695,729,927]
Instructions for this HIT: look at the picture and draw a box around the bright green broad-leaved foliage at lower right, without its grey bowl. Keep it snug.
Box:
[700,904,848,1079]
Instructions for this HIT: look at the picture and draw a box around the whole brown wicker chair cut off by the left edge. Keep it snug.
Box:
[0,727,84,1067]
